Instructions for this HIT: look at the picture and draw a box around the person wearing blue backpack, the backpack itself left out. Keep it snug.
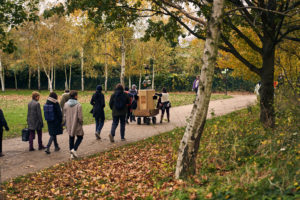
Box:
[45,92,63,154]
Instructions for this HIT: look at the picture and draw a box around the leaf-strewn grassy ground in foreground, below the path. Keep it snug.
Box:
[3,95,300,199]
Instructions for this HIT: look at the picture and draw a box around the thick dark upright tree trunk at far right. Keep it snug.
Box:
[260,33,275,127]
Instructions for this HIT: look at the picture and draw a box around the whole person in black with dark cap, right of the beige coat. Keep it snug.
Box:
[91,85,105,140]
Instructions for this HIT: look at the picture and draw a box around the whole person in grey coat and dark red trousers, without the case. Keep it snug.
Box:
[27,92,45,151]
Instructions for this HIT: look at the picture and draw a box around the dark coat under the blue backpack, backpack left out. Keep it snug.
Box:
[46,98,63,136]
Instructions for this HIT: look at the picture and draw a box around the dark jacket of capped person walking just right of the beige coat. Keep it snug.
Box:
[91,91,105,119]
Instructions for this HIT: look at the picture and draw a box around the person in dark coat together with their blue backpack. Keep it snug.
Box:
[44,92,63,154]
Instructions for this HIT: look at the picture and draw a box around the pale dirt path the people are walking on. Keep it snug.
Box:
[0,95,256,182]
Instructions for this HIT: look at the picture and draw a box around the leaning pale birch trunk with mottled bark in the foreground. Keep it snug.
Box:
[175,0,224,179]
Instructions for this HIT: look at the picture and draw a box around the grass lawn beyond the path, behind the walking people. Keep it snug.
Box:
[0,90,231,138]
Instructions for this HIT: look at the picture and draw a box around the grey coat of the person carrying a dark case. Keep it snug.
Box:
[27,100,44,130]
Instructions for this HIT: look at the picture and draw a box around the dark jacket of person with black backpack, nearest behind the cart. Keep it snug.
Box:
[109,90,130,117]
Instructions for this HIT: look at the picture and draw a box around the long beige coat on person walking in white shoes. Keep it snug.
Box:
[63,99,84,137]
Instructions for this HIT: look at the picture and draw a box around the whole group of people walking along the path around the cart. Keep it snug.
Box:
[0,84,171,159]
